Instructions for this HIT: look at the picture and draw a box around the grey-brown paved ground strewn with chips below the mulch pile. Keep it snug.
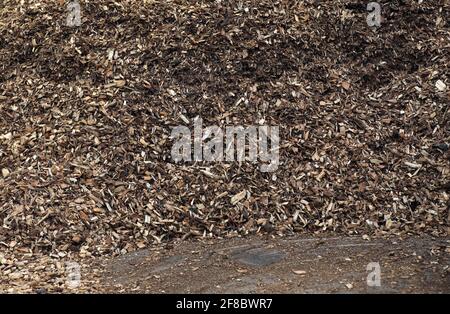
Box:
[102,237,450,293]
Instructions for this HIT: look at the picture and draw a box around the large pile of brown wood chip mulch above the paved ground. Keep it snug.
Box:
[0,0,450,291]
